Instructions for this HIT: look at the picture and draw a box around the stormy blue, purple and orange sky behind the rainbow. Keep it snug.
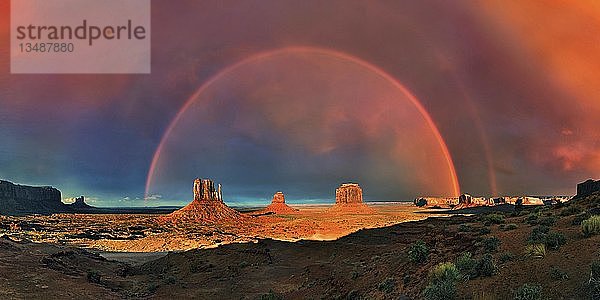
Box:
[0,0,600,206]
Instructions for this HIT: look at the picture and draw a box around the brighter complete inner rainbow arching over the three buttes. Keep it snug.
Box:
[144,47,460,199]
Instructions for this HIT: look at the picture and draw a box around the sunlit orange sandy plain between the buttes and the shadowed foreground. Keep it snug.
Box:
[0,202,440,255]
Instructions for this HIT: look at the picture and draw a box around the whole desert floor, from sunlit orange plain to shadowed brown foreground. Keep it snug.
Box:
[0,196,600,299]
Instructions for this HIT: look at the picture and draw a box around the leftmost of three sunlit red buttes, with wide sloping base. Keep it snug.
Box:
[162,178,243,223]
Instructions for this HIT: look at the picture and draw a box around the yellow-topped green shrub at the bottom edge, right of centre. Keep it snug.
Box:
[423,262,461,300]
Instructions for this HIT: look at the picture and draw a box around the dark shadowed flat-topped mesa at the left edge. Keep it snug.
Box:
[0,180,70,215]
